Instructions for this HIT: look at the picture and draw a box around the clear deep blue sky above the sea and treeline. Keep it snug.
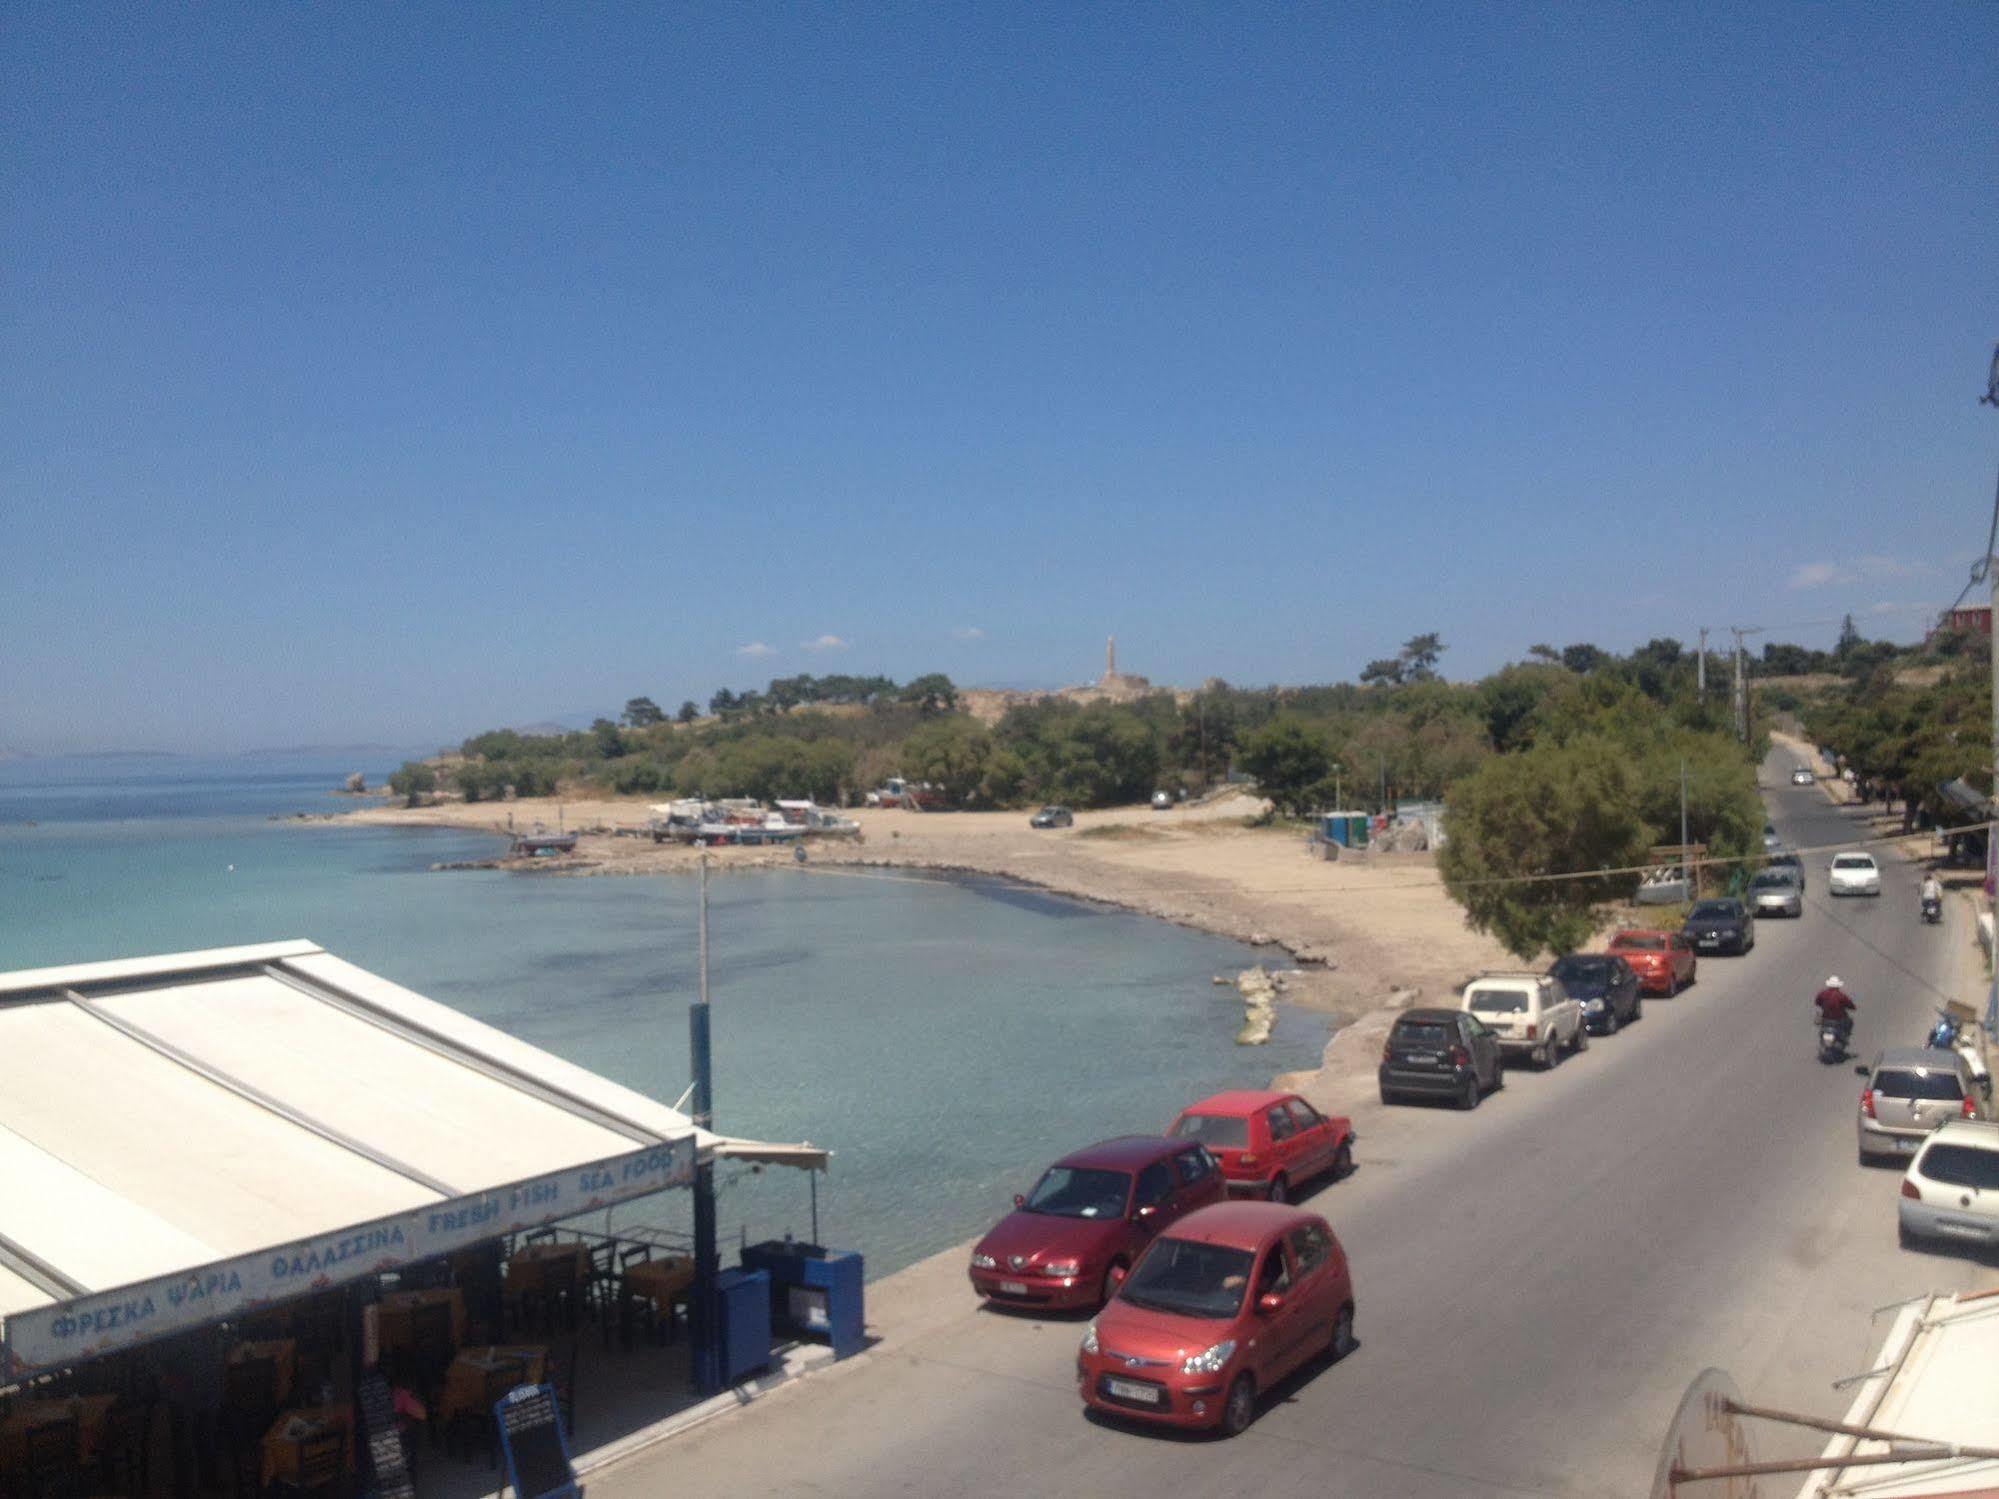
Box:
[0,4,1999,750]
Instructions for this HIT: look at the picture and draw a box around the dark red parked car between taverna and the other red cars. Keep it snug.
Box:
[972,1135,1223,1307]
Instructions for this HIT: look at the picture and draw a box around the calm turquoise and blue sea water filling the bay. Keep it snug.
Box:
[0,755,1323,1275]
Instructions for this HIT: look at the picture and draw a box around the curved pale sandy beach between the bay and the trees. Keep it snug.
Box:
[334,795,1515,1107]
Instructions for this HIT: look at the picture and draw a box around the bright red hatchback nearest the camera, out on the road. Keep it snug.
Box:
[1075,1203,1353,1437]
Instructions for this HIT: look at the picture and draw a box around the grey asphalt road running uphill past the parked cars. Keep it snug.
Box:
[590,753,1995,1499]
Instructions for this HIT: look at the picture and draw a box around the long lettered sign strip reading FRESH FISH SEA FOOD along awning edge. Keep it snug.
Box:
[0,1135,694,1379]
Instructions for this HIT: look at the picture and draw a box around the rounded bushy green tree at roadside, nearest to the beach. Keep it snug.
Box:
[1437,736,1653,961]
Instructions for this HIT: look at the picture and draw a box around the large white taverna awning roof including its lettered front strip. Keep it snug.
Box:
[0,941,828,1379]
